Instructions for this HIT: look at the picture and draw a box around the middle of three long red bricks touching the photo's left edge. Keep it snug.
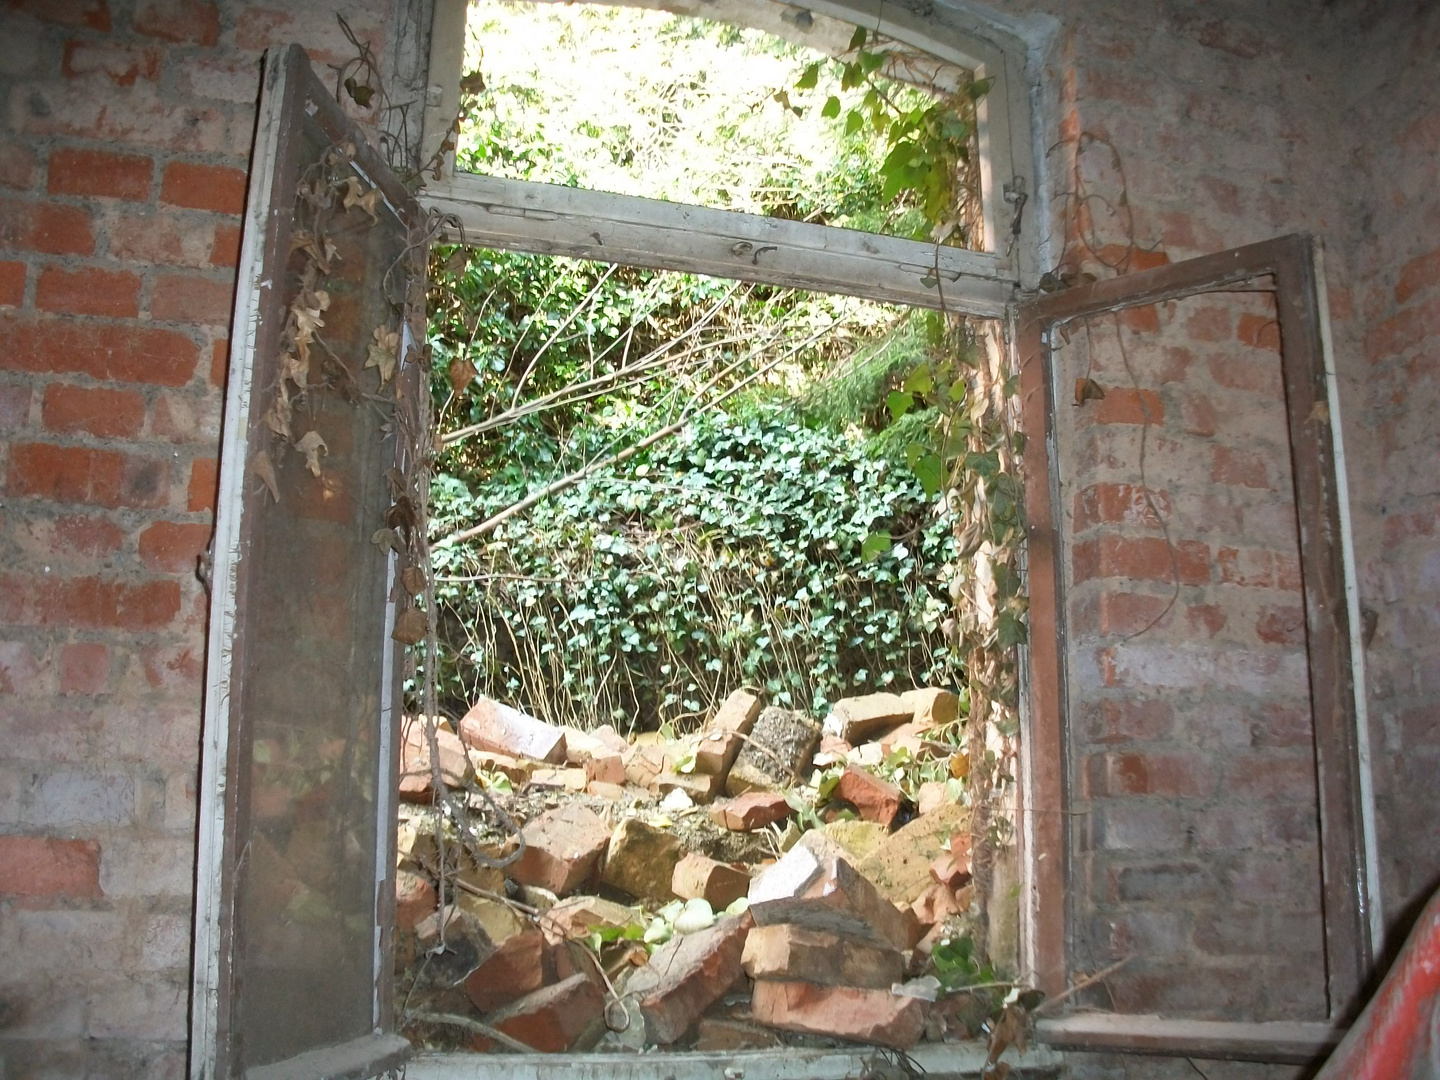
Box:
[6,442,170,507]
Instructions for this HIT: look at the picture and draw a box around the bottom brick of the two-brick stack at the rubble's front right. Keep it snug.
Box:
[750,982,930,1050]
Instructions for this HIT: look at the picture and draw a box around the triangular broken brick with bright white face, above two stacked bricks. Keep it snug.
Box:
[750,829,910,949]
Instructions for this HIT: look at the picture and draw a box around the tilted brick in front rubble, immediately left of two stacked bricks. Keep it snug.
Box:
[625,913,752,1045]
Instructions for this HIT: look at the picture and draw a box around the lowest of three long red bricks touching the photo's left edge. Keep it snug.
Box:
[0,575,180,631]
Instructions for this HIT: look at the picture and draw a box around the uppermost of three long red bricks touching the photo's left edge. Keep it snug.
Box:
[0,317,200,386]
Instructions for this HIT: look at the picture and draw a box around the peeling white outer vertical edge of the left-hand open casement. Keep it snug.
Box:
[190,50,287,1080]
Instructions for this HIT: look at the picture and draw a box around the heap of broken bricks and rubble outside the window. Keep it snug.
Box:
[396,690,978,1051]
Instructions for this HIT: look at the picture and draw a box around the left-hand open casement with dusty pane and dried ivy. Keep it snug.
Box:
[192,46,429,1080]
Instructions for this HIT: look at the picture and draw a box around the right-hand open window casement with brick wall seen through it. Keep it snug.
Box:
[1017,236,1378,1063]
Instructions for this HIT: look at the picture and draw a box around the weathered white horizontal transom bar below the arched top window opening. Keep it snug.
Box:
[420,174,1014,318]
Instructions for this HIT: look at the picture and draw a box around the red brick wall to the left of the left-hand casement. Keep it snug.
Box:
[0,0,406,1080]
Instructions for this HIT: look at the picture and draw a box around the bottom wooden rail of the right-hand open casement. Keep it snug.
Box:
[1035,1012,1345,1064]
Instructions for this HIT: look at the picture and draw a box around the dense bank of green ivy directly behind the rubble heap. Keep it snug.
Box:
[433,406,955,729]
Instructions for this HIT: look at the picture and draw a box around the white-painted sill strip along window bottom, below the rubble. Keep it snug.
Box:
[405,1043,1064,1080]
